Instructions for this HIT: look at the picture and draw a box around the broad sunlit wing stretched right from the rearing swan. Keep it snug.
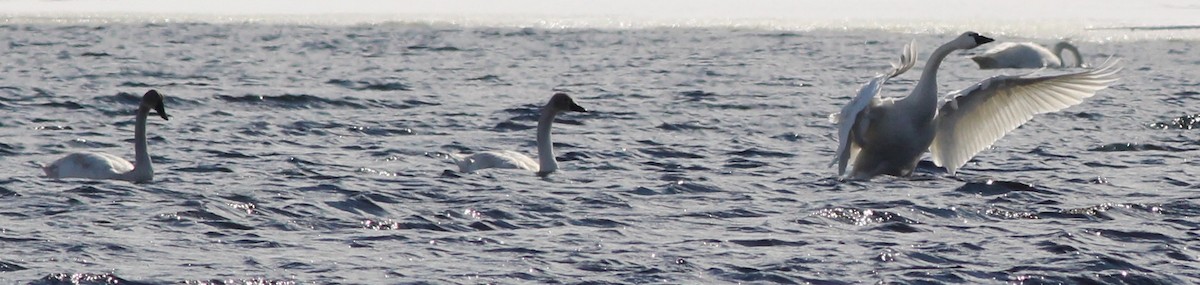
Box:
[929,60,1121,175]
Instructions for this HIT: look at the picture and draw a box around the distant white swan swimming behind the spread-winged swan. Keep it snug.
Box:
[971,42,1084,69]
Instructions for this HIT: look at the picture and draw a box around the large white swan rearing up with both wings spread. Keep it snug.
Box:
[829,32,1121,180]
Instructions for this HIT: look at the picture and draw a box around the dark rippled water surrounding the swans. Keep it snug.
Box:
[0,23,1200,284]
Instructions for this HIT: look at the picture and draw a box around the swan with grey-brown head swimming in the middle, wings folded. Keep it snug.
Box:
[450,92,588,176]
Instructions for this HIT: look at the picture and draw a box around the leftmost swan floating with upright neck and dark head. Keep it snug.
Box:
[42,90,168,182]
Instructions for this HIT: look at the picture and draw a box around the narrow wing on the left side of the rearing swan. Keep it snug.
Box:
[829,41,917,177]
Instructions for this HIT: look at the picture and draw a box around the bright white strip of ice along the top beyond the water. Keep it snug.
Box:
[0,0,1200,42]
